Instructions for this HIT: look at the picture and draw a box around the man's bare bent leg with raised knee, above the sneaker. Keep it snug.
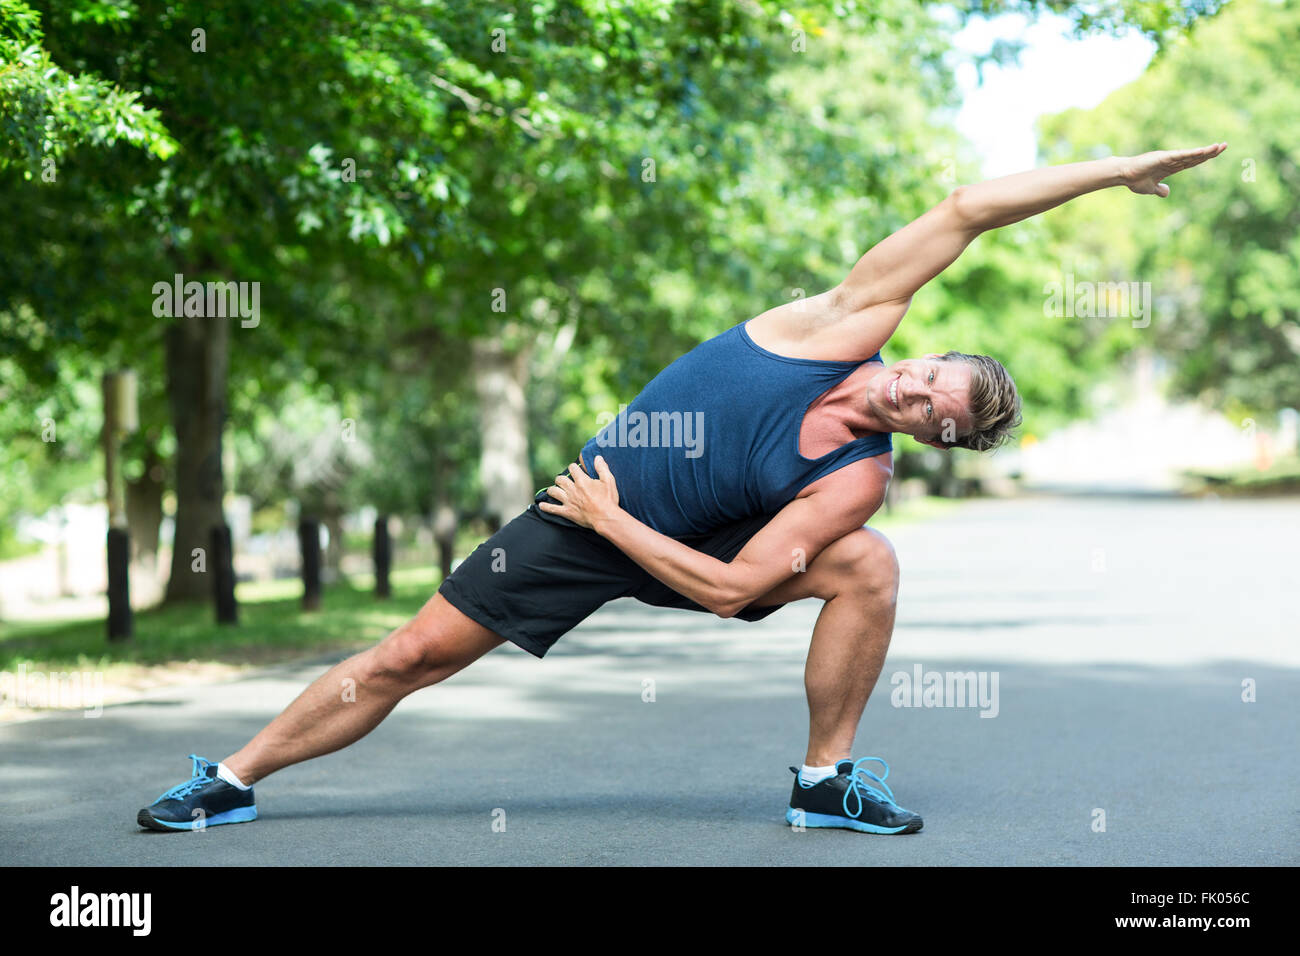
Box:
[754,528,898,766]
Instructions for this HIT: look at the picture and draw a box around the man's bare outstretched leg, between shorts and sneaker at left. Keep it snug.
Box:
[222,594,503,787]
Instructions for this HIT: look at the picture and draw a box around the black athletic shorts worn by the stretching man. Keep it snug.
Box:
[438,492,781,657]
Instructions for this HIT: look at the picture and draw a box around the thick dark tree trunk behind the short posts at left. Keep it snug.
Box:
[165,316,231,601]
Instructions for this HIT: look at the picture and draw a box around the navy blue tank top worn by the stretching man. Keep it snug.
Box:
[582,323,893,537]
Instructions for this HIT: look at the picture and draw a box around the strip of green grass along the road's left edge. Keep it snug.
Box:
[0,567,438,670]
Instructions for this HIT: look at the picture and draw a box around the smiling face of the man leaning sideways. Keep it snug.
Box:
[867,354,971,447]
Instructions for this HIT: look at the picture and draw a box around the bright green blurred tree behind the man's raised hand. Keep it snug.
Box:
[1041,0,1300,414]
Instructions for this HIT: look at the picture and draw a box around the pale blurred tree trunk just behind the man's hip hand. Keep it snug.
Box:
[473,341,536,529]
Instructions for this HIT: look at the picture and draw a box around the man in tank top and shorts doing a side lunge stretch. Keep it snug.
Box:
[138,143,1226,834]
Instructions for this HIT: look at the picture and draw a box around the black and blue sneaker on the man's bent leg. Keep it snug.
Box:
[785,757,922,834]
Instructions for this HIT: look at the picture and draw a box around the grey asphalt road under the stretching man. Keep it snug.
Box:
[0,498,1300,866]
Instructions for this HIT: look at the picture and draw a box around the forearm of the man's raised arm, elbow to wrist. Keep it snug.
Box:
[953,156,1126,232]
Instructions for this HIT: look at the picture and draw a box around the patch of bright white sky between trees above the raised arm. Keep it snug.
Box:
[956,14,1156,178]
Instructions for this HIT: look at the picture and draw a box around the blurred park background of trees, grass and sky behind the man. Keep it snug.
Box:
[0,0,1300,667]
